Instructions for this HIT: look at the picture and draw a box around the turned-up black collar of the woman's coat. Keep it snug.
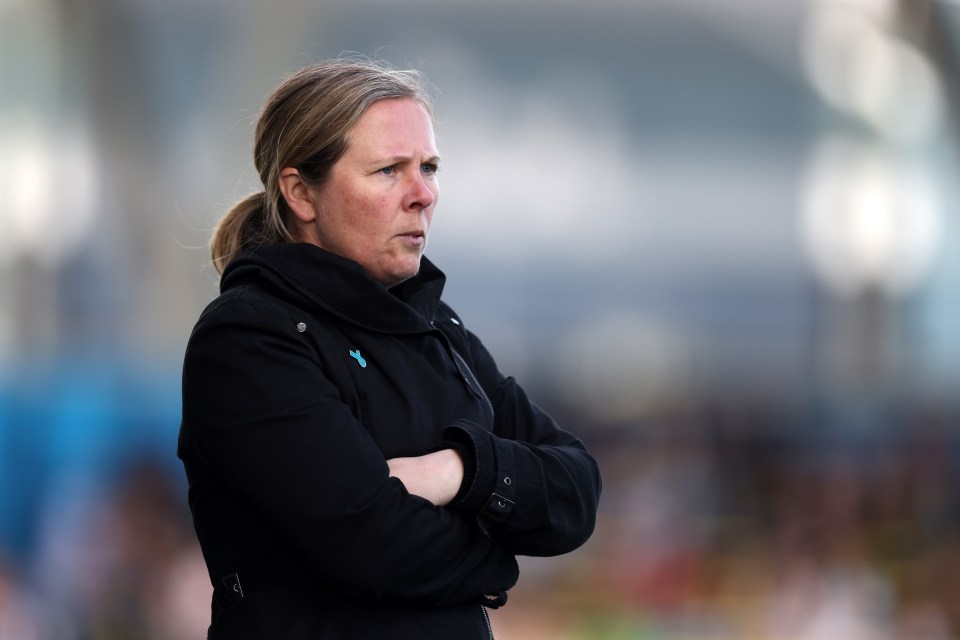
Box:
[220,243,446,333]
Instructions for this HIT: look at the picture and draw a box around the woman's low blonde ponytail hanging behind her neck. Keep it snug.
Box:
[210,191,289,274]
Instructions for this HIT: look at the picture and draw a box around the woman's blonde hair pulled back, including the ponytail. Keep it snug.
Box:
[210,59,432,273]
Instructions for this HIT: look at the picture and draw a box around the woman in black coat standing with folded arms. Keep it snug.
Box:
[178,60,600,640]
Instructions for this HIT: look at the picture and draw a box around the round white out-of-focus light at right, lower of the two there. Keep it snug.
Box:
[801,139,942,295]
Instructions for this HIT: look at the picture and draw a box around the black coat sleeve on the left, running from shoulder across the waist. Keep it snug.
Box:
[181,302,517,604]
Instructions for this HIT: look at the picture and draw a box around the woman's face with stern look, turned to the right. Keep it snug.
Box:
[304,98,440,287]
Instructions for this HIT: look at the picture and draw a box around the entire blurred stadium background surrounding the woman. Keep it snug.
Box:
[0,0,960,640]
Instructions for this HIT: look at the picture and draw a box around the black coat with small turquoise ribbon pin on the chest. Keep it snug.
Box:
[178,244,600,640]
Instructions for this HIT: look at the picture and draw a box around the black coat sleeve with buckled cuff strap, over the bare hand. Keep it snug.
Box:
[444,324,601,556]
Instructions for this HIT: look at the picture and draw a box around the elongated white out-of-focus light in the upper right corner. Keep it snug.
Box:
[802,2,944,142]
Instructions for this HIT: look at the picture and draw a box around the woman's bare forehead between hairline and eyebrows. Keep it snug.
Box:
[347,98,436,155]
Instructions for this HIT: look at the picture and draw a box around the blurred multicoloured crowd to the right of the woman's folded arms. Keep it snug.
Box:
[492,392,960,640]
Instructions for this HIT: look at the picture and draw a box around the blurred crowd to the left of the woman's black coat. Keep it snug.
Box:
[0,460,210,640]
